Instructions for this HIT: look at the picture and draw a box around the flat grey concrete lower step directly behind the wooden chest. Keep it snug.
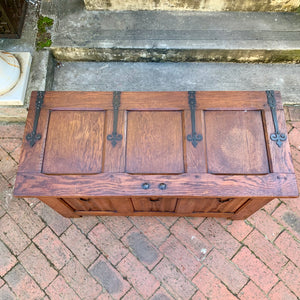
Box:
[52,62,300,105]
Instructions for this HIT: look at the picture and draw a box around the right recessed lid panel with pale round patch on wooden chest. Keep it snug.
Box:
[205,111,269,174]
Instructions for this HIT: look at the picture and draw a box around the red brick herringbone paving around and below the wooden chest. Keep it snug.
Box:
[0,109,300,300]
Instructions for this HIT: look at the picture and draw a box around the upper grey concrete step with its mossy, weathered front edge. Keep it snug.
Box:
[51,6,300,63]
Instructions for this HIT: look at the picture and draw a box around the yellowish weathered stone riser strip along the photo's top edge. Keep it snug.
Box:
[84,0,300,11]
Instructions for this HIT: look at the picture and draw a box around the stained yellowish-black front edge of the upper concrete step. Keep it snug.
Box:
[50,47,300,64]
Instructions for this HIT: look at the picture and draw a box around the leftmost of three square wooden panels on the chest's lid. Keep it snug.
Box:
[43,111,105,174]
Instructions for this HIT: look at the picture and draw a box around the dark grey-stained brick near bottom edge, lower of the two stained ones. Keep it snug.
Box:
[89,256,130,299]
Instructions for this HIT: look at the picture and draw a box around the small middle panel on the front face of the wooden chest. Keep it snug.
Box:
[132,197,177,212]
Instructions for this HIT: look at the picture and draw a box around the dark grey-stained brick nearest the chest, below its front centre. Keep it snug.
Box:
[122,227,162,270]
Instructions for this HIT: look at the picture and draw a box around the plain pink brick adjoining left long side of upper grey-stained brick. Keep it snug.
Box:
[88,223,128,265]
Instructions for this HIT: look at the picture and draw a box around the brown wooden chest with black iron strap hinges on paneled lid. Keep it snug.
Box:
[14,91,298,219]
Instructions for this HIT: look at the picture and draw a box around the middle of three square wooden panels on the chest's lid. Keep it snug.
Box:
[126,111,184,174]
